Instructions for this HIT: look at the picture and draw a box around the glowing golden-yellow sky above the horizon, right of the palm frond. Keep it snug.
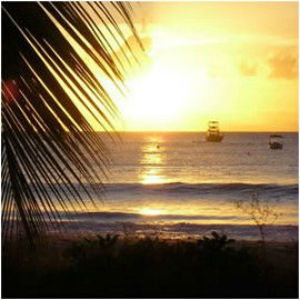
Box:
[79,2,298,131]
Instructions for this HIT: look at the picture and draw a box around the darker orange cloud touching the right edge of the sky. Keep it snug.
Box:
[267,53,298,79]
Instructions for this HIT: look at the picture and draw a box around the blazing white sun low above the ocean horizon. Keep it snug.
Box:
[124,63,188,125]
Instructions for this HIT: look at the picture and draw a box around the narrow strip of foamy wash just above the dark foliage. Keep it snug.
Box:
[47,220,299,242]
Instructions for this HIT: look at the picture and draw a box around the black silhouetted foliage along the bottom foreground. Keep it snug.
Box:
[2,235,298,298]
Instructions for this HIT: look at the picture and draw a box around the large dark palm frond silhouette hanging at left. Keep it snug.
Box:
[1,2,142,242]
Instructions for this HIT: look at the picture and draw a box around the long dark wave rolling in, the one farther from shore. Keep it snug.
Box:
[24,182,299,199]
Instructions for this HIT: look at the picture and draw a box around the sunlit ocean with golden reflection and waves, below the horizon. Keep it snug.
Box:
[58,132,298,240]
